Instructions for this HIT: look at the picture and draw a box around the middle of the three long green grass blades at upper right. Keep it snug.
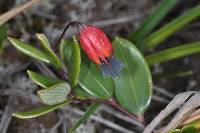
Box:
[145,5,200,48]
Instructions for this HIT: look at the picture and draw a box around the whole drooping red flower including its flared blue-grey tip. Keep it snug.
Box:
[79,24,124,77]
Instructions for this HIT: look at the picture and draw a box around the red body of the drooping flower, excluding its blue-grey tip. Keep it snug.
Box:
[79,25,112,65]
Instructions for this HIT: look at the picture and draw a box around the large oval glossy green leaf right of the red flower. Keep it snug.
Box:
[113,37,152,115]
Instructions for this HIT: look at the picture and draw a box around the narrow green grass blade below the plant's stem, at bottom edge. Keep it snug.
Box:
[69,103,100,133]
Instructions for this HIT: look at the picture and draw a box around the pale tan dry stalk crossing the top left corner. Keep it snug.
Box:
[0,0,40,25]
